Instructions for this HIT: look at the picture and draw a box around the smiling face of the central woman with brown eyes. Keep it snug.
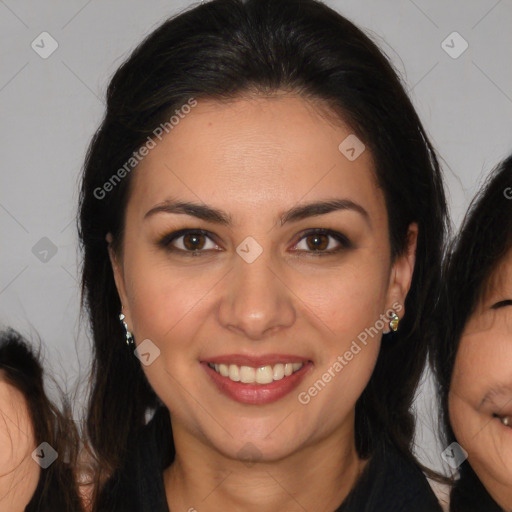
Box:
[111,95,416,460]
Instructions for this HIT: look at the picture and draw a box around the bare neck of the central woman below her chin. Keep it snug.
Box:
[164,423,366,512]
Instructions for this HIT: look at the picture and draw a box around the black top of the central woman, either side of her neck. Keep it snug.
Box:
[100,407,442,512]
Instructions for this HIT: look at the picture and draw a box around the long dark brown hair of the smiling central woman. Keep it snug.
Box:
[78,0,447,504]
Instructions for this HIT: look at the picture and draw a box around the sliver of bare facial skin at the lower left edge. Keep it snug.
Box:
[0,371,40,512]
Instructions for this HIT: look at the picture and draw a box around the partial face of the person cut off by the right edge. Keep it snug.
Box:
[449,251,512,510]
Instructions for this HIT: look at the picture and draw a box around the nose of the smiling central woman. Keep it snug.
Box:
[218,251,296,340]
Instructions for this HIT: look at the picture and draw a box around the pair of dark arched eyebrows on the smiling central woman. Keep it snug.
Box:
[144,199,371,227]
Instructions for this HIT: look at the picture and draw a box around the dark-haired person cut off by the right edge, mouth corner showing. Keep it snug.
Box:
[433,156,512,512]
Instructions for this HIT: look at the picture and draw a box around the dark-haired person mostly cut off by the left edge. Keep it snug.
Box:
[0,329,83,512]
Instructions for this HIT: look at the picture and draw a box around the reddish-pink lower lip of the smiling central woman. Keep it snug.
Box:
[201,362,313,405]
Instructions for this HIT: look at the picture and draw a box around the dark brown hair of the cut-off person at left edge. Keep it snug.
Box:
[0,328,83,512]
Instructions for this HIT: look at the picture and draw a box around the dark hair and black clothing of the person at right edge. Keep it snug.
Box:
[431,151,512,512]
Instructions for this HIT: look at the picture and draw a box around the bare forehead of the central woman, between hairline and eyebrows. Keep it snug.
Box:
[128,95,385,226]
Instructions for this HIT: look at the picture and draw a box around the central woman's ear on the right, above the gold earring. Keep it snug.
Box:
[386,222,418,318]
